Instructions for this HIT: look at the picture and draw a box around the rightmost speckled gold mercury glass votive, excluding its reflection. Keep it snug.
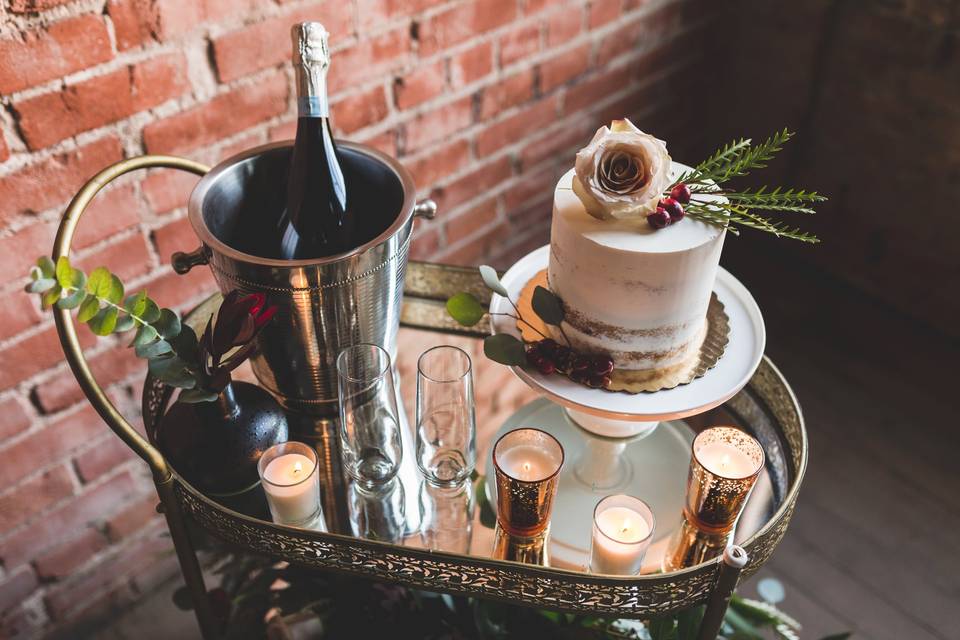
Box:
[684,427,764,533]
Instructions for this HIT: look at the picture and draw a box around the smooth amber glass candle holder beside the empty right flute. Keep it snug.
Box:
[493,429,563,538]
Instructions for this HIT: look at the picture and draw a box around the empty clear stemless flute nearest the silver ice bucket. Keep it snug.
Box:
[337,344,403,488]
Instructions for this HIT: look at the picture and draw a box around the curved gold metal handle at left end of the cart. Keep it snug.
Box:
[53,156,210,482]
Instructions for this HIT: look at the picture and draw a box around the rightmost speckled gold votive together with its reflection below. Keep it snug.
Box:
[663,427,764,571]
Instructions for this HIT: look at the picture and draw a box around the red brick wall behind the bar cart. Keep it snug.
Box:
[0,0,702,636]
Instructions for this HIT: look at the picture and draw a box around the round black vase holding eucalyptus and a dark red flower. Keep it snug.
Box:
[157,381,287,497]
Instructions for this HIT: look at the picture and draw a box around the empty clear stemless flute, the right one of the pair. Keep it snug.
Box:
[417,345,477,486]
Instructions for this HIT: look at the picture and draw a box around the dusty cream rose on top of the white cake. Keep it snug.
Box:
[573,119,670,220]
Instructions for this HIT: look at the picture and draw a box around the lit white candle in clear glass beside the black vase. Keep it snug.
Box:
[257,442,325,529]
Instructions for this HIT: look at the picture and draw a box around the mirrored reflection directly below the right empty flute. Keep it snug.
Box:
[420,480,476,554]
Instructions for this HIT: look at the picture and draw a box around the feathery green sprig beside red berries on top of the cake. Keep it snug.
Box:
[664,129,826,243]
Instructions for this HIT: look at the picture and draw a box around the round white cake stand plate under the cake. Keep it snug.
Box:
[490,245,766,438]
